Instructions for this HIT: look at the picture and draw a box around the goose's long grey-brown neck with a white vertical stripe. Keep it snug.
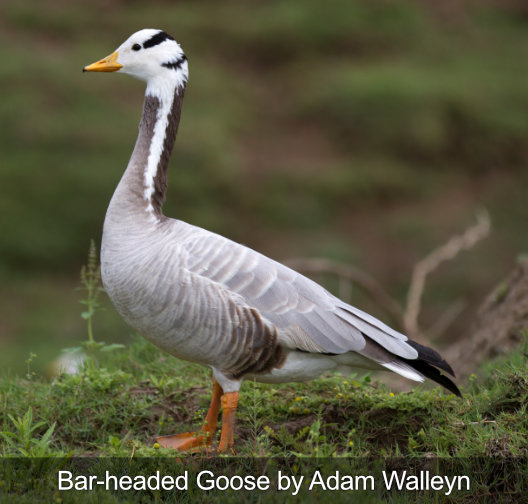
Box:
[107,87,184,221]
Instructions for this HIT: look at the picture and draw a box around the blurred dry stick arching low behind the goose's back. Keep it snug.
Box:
[286,258,404,330]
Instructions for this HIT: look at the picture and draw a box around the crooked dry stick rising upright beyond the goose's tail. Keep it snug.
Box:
[403,209,490,340]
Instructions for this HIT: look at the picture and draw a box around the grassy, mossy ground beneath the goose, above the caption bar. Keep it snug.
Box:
[0,337,528,502]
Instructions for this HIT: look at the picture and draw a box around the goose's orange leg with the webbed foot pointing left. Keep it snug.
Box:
[156,379,224,451]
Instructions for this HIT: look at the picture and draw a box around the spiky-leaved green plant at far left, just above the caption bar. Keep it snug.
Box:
[0,406,55,457]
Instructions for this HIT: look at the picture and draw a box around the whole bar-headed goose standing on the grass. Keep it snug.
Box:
[84,29,459,452]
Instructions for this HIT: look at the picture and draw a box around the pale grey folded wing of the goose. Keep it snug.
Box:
[183,228,418,359]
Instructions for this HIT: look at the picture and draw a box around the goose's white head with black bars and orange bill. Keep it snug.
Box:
[83,28,189,94]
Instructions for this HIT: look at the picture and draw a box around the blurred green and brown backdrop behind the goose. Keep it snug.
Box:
[0,0,528,372]
